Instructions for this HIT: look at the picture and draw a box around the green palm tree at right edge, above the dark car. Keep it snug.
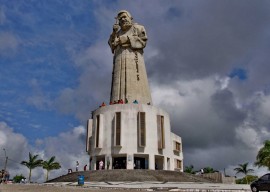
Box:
[255,140,270,171]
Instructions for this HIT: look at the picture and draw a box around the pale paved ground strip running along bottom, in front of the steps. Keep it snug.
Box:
[0,181,251,192]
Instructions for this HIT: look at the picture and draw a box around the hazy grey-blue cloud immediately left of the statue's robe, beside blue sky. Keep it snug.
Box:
[55,40,113,122]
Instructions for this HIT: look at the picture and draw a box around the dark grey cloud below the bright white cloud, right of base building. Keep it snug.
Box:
[171,90,246,149]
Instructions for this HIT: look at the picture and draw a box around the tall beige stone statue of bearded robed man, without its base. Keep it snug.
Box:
[108,10,152,104]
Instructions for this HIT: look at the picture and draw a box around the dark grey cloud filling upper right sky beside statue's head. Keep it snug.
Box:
[144,1,270,82]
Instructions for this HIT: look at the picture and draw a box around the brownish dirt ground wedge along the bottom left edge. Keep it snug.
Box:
[0,184,150,192]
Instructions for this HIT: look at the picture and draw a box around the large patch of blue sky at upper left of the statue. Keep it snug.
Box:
[0,1,96,141]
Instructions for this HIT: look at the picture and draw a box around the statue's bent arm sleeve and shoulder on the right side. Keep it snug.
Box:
[129,25,147,49]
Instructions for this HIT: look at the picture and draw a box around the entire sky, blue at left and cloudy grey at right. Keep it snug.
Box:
[0,0,270,181]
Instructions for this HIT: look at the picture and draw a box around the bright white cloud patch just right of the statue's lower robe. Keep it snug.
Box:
[152,77,220,118]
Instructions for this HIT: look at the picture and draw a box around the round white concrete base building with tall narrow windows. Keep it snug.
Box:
[87,104,183,171]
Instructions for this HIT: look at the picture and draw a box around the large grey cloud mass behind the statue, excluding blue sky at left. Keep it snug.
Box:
[53,0,270,174]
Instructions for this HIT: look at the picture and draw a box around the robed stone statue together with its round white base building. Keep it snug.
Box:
[86,10,183,172]
